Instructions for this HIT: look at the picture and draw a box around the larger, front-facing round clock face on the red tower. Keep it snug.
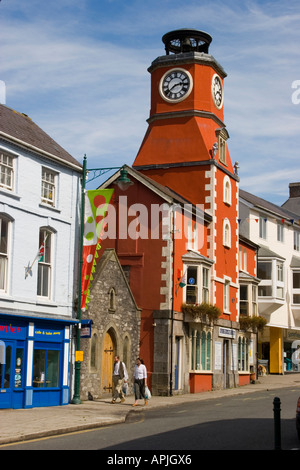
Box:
[159,68,193,103]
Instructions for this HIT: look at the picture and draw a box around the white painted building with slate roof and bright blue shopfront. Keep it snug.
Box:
[0,105,82,408]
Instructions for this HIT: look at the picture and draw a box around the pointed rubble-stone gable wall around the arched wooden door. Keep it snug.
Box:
[80,249,140,400]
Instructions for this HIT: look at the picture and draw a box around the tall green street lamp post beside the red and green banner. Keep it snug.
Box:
[72,155,133,405]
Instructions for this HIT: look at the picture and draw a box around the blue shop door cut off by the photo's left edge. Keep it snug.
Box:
[0,341,14,408]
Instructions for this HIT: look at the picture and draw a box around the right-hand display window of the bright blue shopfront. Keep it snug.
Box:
[33,349,60,388]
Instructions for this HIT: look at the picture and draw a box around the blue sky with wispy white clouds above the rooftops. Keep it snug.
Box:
[0,0,300,205]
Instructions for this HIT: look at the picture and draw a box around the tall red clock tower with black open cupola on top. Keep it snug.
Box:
[133,29,238,326]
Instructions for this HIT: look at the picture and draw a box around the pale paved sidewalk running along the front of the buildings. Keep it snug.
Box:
[0,374,300,445]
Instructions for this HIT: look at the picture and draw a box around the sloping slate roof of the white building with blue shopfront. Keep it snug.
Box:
[0,104,82,171]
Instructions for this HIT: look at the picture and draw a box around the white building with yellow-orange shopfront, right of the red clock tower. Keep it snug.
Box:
[239,190,300,374]
